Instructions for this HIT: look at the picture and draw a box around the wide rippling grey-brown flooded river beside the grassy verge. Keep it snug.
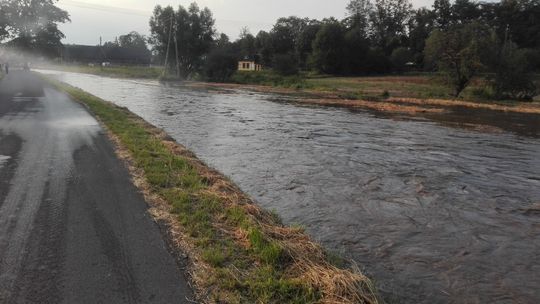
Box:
[43,73,540,303]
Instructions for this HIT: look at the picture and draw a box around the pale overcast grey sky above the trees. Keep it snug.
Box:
[58,0,433,45]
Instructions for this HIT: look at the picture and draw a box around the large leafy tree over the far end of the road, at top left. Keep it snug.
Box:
[0,0,69,57]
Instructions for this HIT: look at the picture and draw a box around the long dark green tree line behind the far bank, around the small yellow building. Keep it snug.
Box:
[150,0,540,98]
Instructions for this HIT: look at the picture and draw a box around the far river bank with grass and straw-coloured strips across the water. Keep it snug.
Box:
[38,66,540,114]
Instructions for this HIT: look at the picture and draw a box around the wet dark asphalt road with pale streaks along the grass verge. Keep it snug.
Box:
[0,71,192,303]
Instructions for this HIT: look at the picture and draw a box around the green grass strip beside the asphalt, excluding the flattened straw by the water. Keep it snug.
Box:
[44,76,338,303]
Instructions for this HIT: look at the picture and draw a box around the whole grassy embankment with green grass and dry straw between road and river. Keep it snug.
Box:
[44,79,378,303]
